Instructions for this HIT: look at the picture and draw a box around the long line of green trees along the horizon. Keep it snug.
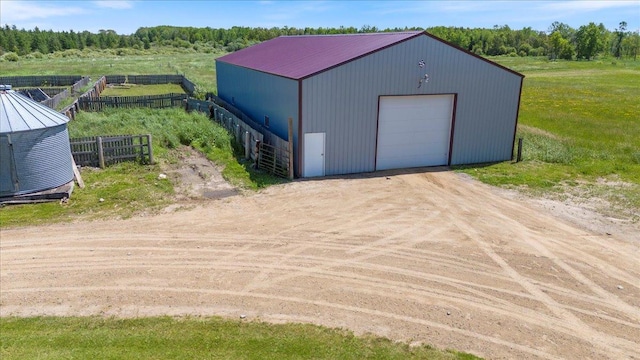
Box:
[0,21,640,60]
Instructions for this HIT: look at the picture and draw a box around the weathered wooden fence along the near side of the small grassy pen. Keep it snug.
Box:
[78,93,187,111]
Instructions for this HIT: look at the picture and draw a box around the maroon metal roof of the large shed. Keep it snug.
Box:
[216,31,425,80]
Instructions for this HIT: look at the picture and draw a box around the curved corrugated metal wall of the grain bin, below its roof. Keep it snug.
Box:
[2,124,73,196]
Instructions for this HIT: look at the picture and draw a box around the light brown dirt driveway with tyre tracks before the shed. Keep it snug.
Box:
[0,171,640,359]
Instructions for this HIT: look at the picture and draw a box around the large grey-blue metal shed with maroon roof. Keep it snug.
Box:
[216,31,524,177]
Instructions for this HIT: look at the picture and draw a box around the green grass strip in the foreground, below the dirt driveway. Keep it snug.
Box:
[0,317,478,360]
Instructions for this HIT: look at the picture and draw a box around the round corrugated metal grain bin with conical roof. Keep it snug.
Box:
[0,85,74,198]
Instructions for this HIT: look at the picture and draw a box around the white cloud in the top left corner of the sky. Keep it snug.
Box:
[0,0,87,24]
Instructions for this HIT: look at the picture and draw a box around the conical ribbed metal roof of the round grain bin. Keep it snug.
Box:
[0,90,69,134]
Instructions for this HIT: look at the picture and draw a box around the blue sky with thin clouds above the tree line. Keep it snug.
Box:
[0,0,640,34]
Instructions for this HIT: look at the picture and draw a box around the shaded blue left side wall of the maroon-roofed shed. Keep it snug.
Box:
[216,62,298,160]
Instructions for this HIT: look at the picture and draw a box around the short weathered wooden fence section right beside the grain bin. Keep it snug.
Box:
[69,134,153,168]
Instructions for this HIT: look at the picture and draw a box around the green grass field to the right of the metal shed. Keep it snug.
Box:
[462,57,640,221]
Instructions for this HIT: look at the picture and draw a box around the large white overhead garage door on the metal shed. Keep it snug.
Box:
[376,95,453,170]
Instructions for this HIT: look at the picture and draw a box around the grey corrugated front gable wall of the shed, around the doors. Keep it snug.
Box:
[302,35,521,175]
